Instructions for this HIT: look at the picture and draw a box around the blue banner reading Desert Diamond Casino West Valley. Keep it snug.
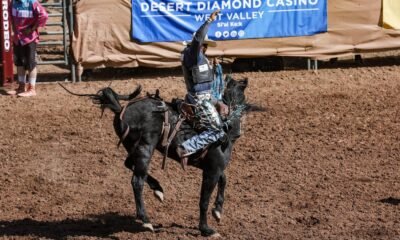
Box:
[132,0,327,42]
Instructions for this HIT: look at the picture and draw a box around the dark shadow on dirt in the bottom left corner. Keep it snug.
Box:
[0,213,151,239]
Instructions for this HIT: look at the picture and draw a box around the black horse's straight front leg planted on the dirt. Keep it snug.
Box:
[199,171,221,237]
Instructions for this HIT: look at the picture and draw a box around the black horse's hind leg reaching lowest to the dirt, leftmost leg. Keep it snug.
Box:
[131,144,154,231]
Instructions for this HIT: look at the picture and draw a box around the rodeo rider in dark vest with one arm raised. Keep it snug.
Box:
[177,10,228,169]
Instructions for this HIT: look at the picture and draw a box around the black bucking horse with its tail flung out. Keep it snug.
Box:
[60,75,249,236]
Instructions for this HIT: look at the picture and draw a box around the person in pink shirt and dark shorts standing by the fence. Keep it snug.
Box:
[7,0,48,97]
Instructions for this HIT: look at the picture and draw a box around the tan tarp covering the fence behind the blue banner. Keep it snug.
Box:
[73,0,400,68]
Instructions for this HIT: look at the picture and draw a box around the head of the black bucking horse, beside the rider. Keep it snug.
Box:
[223,75,248,140]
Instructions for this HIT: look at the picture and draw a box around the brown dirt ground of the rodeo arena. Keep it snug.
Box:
[0,53,400,240]
